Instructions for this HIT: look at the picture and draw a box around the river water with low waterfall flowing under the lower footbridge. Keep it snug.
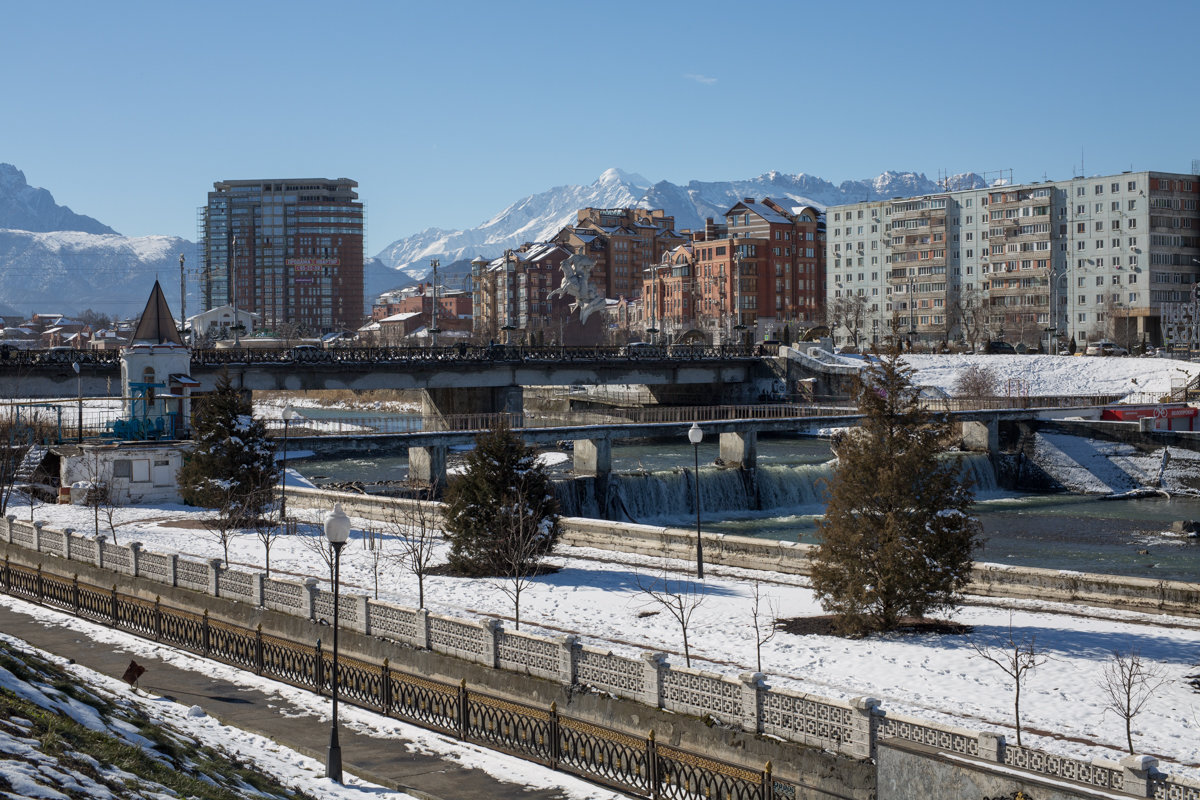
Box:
[290,422,1200,582]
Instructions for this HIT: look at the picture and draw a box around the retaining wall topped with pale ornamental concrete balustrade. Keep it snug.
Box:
[0,513,1200,800]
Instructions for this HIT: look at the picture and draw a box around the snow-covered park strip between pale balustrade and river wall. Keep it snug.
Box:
[17,496,1200,777]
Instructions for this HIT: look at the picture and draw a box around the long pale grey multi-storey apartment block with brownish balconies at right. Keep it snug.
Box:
[826,172,1200,347]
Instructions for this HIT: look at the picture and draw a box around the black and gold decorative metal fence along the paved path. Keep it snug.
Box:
[2,559,782,800]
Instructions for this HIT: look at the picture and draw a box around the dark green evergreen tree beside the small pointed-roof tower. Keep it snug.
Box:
[179,374,280,527]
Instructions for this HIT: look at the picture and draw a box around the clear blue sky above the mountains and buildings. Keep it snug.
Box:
[0,0,1200,254]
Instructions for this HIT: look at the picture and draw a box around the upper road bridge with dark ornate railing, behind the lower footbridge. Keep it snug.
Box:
[0,344,766,414]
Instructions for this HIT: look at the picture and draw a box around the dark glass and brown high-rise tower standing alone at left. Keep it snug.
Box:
[199,178,364,333]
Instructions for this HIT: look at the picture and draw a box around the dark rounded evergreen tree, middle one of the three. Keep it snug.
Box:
[444,425,559,577]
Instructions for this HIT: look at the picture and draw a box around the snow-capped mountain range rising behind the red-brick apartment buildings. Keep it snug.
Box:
[377,169,986,279]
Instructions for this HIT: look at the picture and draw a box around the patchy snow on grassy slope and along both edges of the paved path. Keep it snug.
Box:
[0,596,623,800]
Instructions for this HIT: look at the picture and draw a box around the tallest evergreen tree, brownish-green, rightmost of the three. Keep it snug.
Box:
[812,348,980,633]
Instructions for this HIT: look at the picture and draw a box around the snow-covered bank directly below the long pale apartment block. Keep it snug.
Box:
[839,354,1200,402]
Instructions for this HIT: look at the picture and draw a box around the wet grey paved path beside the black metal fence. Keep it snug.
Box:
[0,603,620,800]
